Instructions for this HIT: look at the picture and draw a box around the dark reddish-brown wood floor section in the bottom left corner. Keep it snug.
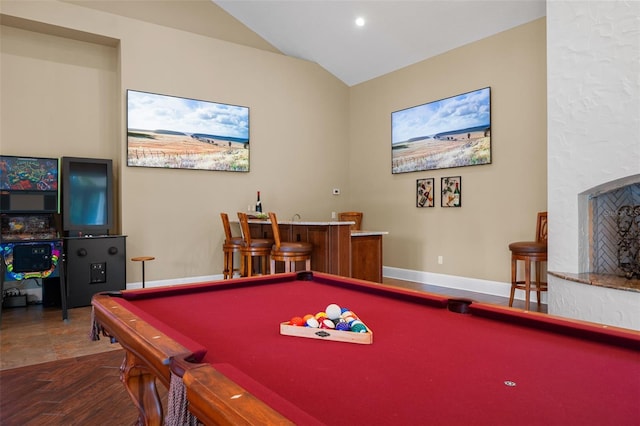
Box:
[0,350,151,426]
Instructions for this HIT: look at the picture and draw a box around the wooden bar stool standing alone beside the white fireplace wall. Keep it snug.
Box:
[509,212,547,311]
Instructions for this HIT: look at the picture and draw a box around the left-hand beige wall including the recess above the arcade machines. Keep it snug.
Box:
[0,1,348,282]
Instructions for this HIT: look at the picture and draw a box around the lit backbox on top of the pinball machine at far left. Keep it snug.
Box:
[0,155,59,213]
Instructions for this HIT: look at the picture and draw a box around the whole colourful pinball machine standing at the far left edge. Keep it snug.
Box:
[0,155,67,320]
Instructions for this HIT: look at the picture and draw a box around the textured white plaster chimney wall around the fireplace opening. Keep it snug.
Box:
[547,0,640,326]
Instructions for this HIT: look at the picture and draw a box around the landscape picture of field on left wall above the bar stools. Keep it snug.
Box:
[127,90,249,172]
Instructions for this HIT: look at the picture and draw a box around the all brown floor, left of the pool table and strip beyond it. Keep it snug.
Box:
[0,278,546,426]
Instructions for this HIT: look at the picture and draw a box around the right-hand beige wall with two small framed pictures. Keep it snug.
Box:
[349,19,547,282]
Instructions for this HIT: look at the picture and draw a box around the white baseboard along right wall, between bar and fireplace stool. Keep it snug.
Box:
[382,266,547,303]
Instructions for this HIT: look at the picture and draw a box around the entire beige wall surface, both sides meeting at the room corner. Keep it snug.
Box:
[0,1,546,288]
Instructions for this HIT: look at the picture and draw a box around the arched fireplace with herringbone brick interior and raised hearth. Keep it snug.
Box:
[549,174,640,330]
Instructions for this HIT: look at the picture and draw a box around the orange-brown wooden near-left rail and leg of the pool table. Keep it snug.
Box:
[93,293,293,426]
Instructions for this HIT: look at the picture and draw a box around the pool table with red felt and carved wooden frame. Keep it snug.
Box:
[93,271,640,425]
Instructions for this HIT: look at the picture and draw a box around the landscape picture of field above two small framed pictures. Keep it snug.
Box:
[391,87,491,174]
